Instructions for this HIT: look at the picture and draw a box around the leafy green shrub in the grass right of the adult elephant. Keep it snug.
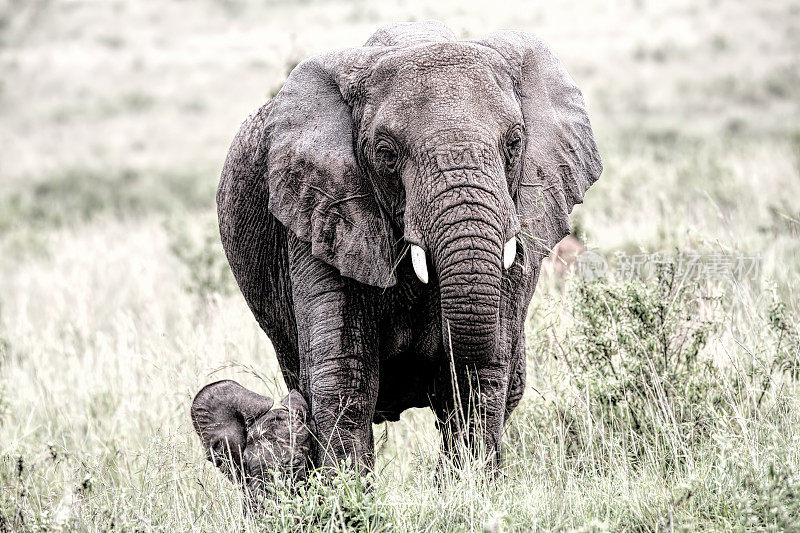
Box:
[558,261,724,467]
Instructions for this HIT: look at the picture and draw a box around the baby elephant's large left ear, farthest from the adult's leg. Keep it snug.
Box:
[191,380,275,481]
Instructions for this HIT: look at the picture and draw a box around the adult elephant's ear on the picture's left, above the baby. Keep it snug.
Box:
[262,47,396,287]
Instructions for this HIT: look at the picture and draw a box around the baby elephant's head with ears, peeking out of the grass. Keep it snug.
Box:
[192,380,311,491]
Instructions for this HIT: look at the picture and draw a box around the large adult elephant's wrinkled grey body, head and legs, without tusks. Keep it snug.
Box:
[200,22,602,486]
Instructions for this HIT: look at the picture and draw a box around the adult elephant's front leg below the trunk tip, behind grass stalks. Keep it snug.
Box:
[432,362,509,470]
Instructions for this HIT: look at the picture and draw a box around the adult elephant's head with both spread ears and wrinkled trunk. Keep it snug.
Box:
[254,22,602,362]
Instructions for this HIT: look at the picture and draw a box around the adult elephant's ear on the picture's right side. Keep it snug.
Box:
[477,31,603,265]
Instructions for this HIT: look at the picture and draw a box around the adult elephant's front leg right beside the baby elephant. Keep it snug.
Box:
[289,237,379,471]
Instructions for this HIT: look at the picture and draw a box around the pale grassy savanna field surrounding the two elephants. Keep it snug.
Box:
[0,0,800,531]
